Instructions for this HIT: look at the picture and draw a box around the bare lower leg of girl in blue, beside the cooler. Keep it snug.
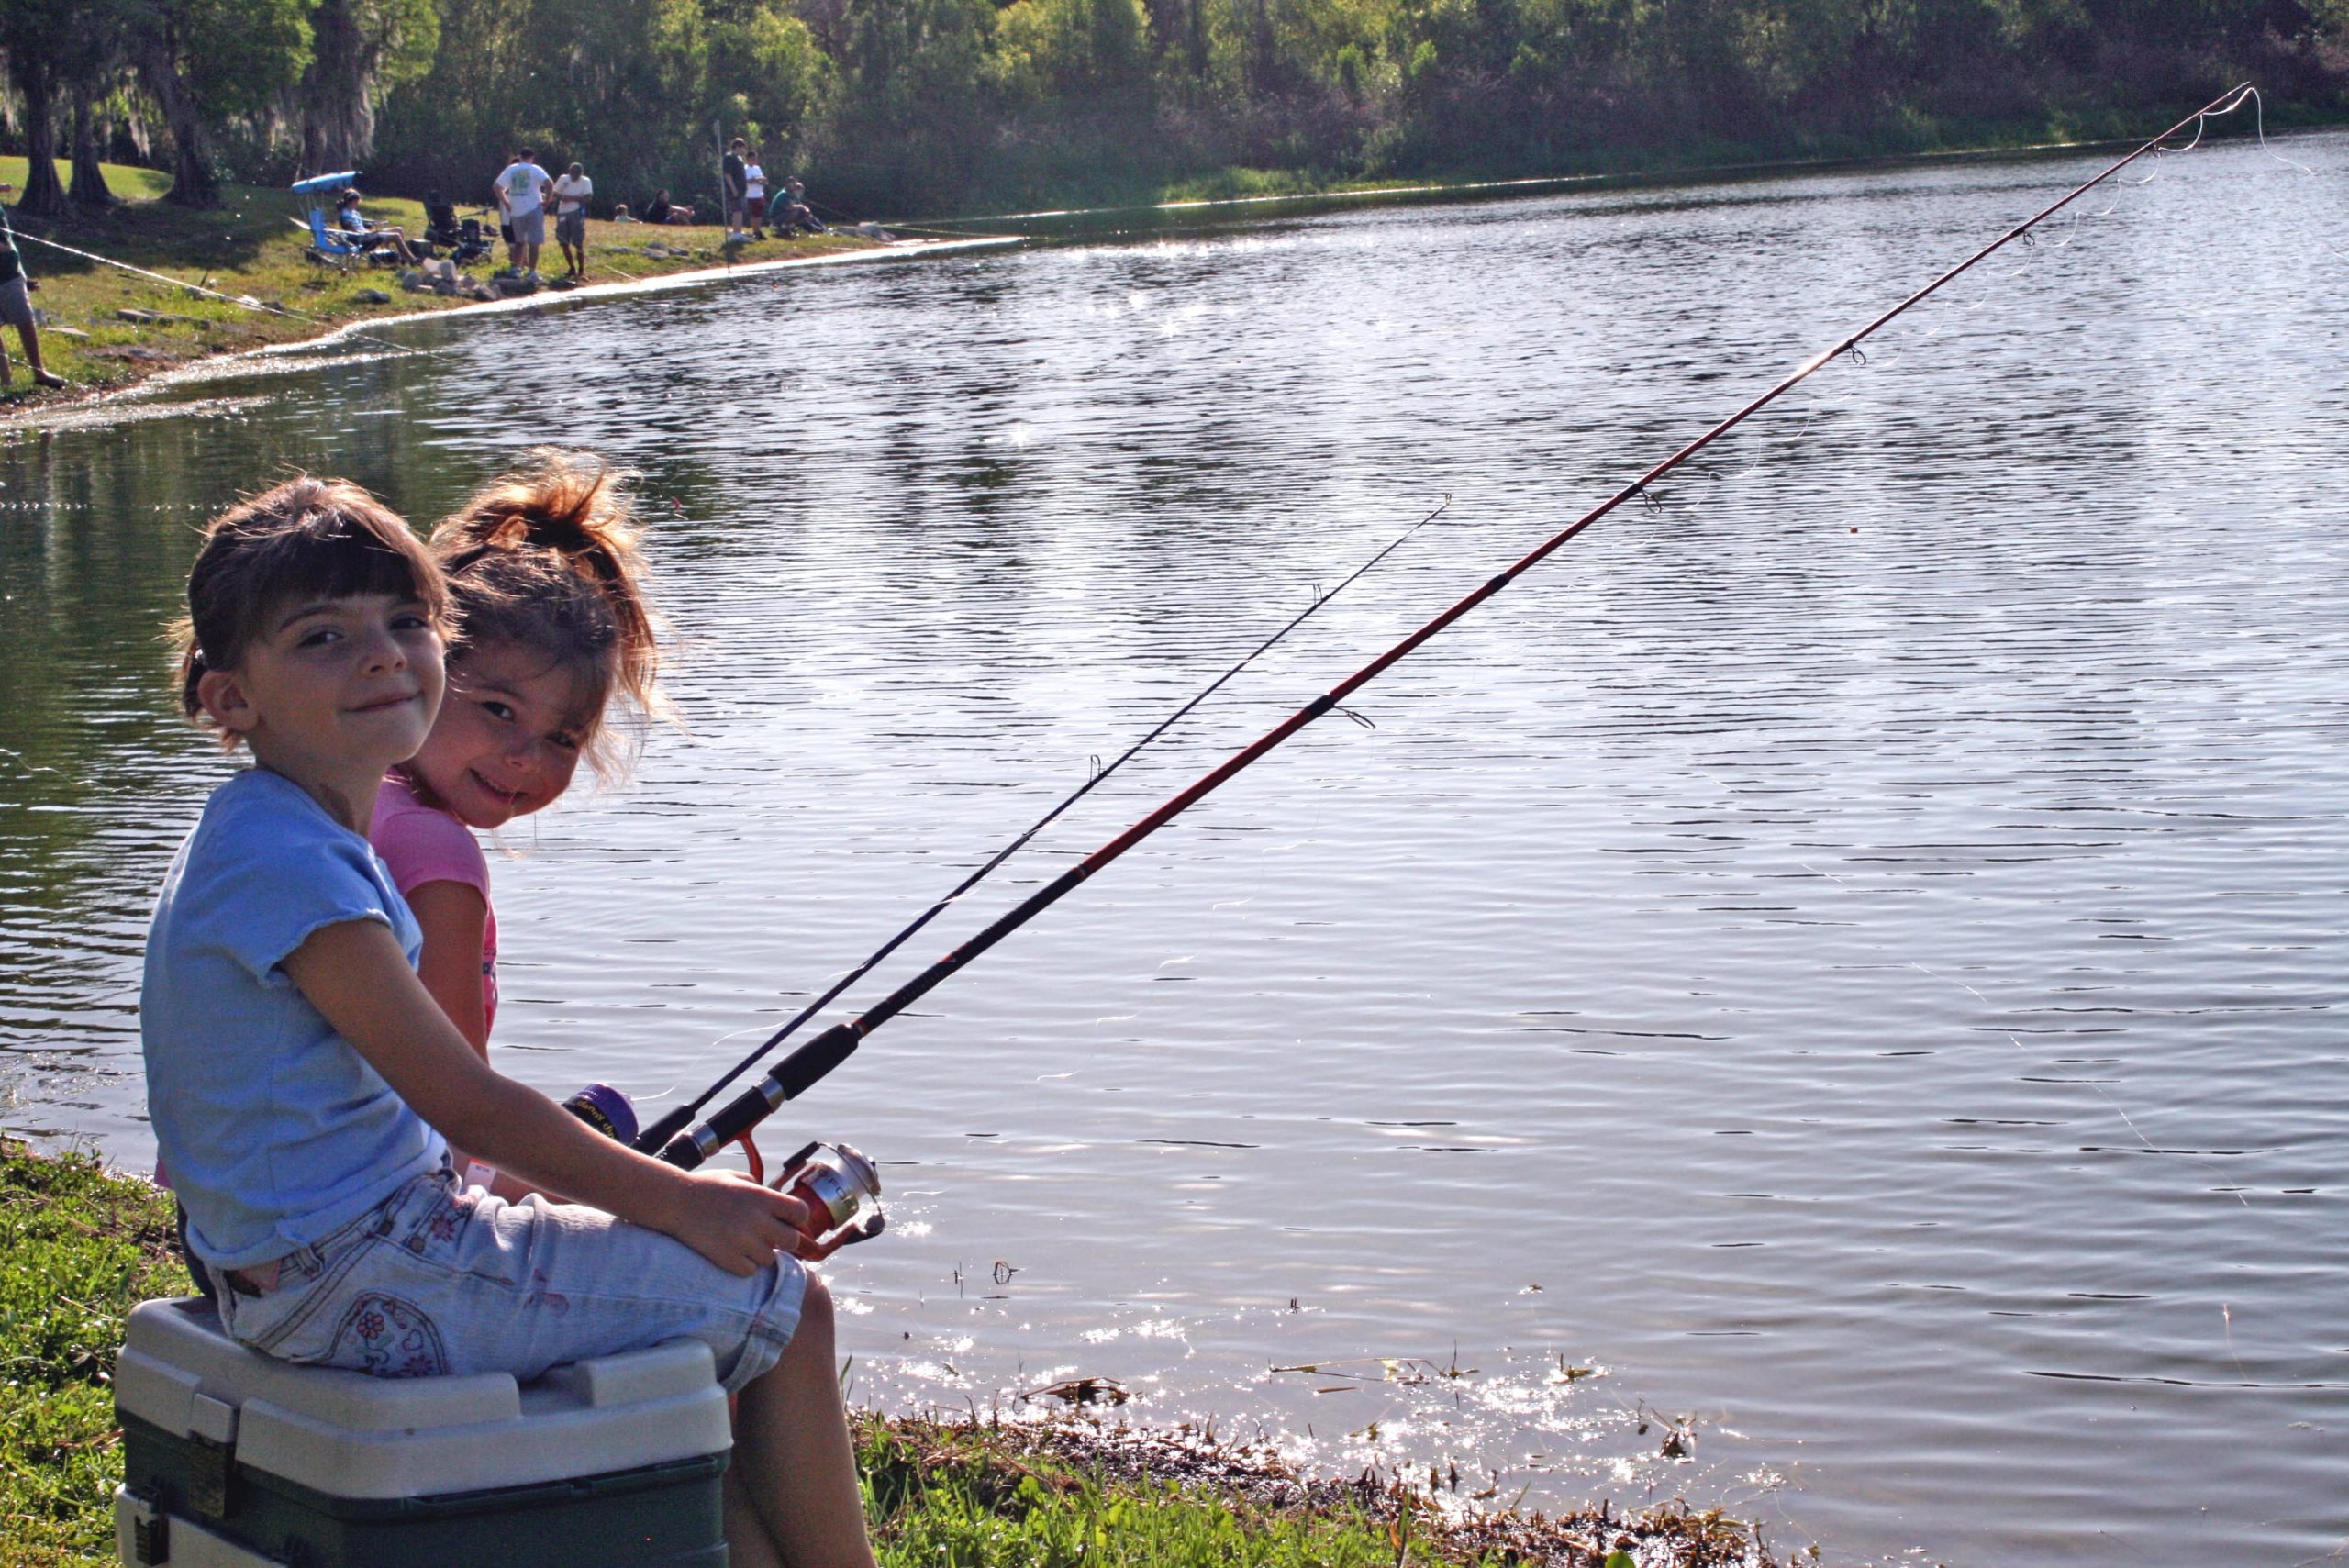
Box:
[729,1274,874,1568]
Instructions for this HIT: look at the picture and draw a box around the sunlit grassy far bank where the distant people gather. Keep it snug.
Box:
[0,157,878,420]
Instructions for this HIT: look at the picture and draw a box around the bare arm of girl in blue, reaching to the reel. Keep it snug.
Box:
[284,920,806,1274]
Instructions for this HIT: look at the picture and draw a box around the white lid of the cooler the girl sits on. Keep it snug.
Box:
[115,1300,733,1497]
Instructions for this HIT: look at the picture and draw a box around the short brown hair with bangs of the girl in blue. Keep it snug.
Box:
[173,474,449,728]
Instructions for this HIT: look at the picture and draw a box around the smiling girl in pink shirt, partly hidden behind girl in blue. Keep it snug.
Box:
[366,449,660,1061]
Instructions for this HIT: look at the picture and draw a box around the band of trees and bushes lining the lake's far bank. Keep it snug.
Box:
[0,0,2349,218]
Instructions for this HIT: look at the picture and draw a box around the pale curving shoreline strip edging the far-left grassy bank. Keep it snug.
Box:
[0,235,1024,439]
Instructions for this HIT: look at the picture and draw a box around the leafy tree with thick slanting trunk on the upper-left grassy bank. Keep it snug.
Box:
[127,0,310,206]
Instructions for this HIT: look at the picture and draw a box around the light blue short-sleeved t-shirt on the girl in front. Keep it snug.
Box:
[139,768,446,1268]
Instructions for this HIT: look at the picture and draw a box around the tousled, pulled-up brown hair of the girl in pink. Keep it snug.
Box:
[432,446,667,770]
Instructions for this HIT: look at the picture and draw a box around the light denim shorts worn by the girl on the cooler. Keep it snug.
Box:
[218,1169,808,1392]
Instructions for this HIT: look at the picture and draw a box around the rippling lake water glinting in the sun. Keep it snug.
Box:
[0,134,2349,1565]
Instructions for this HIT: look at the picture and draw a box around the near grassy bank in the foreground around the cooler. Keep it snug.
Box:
[0,1139,1776,1568]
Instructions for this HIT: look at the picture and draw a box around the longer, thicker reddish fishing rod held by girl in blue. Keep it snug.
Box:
[660,83,2255,1169]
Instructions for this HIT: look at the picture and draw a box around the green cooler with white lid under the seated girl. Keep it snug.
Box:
[115,1300,733,1568]
